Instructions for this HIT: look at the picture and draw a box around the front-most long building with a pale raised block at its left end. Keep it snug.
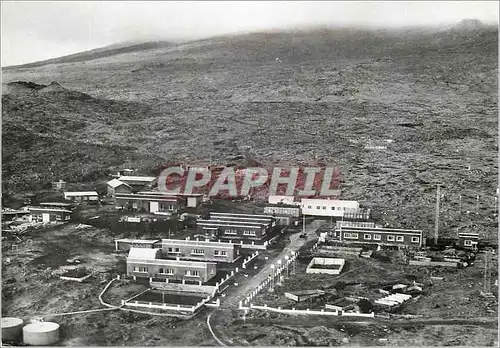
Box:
[127,248,217,284]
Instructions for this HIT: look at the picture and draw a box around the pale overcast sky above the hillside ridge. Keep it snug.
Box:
[1,1,499,66]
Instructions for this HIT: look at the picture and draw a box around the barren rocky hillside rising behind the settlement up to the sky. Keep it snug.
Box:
[2,21,498,240]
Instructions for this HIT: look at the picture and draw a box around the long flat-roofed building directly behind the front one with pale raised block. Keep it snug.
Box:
[162,239,240,263]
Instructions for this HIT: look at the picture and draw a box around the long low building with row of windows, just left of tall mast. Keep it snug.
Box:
[332,227,423,247]
